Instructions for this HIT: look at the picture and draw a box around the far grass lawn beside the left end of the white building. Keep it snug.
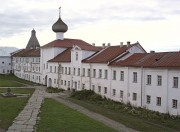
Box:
[0,74,35,87]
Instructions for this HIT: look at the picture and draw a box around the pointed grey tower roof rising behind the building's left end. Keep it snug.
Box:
[26,29,40,49]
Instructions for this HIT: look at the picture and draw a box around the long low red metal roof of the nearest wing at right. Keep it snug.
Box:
[110,52,180,68]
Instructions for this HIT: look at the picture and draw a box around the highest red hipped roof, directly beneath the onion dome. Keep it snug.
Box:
[42,39,102,51]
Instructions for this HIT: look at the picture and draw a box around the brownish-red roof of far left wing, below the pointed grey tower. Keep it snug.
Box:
[13,48,40,57]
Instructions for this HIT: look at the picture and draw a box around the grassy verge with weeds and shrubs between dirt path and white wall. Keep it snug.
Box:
[69,90,180,132]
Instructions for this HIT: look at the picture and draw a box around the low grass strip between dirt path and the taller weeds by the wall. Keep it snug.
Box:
[69,98,180,132]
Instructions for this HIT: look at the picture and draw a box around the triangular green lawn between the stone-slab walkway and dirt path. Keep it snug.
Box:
[37,99,115,132]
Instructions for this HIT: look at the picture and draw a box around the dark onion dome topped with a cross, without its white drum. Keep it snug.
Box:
[52,8,68,33]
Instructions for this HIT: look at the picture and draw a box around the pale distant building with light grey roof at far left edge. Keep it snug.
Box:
[0,47,18,74]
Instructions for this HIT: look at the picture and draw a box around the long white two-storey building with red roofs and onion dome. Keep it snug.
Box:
[13,8,180,115]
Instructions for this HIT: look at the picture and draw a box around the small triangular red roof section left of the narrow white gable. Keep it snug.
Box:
[48,48,72,62]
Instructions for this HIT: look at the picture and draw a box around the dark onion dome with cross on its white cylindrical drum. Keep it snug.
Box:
[52,7,68,40]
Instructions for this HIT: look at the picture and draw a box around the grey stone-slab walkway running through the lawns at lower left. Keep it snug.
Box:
[7,86,46,132]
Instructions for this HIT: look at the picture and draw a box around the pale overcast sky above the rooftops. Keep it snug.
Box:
[0,0,180,52]
